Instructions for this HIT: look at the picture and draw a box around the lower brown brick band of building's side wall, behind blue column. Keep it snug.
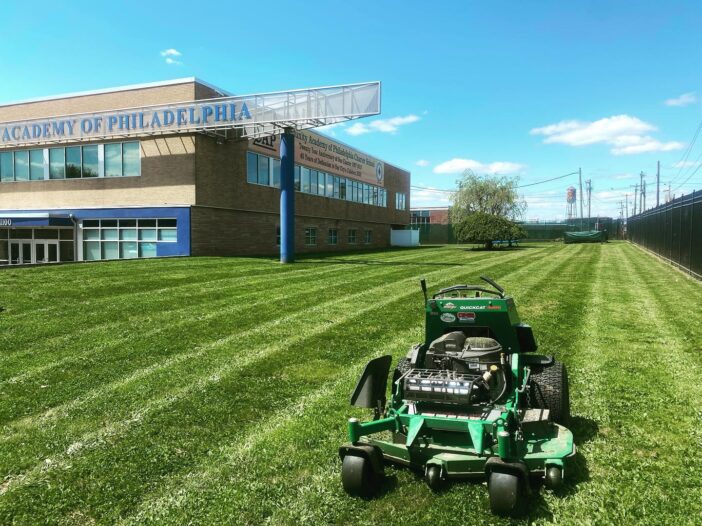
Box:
[190,206,390,256]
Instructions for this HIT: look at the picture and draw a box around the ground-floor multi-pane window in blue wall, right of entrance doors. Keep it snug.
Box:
[83,218,178,261]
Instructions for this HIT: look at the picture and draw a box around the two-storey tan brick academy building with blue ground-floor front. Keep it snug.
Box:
[0,78,410,264]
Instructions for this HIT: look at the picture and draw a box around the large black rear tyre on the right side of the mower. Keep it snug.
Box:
[529,360,570,424]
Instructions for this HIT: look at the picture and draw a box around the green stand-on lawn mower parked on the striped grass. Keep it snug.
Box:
[339,276,575,516]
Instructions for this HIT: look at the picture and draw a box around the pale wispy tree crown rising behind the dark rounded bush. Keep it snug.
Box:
[451,170,526,224]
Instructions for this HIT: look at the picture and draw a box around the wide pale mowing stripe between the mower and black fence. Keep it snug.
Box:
[552,244,702,524]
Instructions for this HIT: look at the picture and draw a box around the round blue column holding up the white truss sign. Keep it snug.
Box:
[280,128,295,263]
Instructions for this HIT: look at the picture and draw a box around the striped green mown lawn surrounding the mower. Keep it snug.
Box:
[0,243,702,525]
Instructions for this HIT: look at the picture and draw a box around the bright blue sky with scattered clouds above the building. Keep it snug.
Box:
[0,0,702,219]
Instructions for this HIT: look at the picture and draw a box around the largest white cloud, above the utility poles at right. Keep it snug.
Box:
[529,115,685,155]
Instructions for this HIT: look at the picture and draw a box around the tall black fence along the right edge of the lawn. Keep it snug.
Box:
[627,190,702,279]
